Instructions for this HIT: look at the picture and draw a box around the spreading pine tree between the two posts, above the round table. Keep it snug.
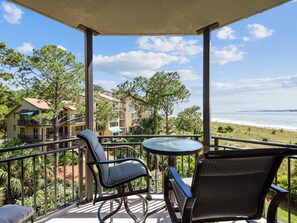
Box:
[115,71,190,134]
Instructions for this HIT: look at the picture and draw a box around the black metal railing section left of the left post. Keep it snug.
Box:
[0,139,84,216]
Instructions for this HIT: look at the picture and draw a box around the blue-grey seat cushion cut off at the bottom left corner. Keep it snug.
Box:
[0,204,34,223]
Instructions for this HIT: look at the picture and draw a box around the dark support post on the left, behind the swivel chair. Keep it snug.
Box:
[85,28,94,201]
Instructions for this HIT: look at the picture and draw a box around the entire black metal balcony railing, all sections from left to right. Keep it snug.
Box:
[0,135,297,223]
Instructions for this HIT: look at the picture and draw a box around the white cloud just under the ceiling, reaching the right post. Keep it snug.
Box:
[138,36,202,55]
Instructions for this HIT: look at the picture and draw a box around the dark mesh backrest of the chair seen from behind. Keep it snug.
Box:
[191,148,290,221]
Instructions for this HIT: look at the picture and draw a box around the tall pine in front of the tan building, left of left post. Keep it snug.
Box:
[16,45,84,140]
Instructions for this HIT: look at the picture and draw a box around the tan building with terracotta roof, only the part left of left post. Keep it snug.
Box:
[7,98,85,142]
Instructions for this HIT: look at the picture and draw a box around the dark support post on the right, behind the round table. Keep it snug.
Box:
[203,26,211,152]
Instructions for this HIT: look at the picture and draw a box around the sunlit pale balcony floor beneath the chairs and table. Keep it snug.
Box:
[35,194,266,223]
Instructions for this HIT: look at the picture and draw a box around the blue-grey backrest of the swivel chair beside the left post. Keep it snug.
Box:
[77,129,109,184]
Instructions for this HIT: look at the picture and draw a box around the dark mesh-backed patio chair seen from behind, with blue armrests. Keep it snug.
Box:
[164,148,296,223]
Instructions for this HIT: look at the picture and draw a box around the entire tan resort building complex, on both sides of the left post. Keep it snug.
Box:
[7,91,149,142]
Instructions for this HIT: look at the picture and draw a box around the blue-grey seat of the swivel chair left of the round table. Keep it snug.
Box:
[108,161,147,186]
